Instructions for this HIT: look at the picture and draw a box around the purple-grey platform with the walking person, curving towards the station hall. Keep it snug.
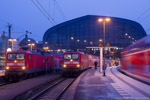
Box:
[65,66,150,100]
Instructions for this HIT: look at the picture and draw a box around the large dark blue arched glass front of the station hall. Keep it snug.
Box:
[43,15,146,50]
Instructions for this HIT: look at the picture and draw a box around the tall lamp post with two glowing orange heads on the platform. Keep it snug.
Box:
[98,18,110,76]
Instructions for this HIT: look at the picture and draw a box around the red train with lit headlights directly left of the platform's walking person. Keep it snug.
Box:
[63,52,99,75]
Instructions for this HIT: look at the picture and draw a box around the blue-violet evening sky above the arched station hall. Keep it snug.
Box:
[0,0,150,41]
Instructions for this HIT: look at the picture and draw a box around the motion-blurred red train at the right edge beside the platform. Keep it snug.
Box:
[121,36,150,79]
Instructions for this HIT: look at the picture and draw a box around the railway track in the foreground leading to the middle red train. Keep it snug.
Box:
[13,77,75,100]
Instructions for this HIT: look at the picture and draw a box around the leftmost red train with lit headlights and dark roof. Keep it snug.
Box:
[5,51,62,80]
